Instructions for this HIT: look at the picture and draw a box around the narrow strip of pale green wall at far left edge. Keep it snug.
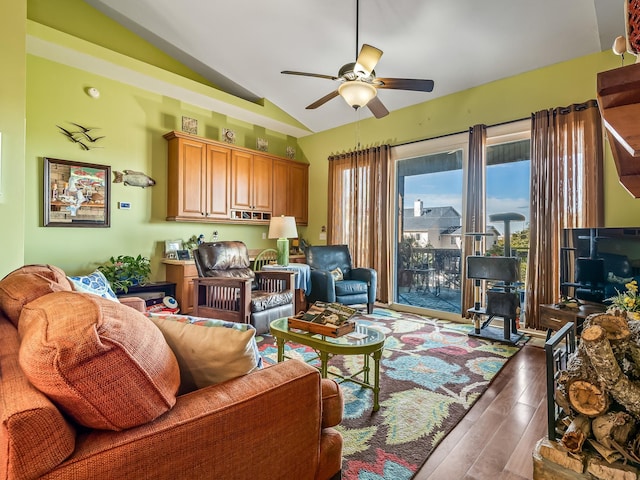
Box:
[0,0,27,277]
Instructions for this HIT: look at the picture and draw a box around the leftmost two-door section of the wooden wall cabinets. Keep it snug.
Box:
[165,132,231,222]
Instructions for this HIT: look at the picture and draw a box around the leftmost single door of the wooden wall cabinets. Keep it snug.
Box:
[168,139,207,218]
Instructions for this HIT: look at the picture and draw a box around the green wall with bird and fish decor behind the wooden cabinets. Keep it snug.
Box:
[24,48,304,279]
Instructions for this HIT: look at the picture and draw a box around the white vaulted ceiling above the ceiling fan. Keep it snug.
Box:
[86,0,624,132]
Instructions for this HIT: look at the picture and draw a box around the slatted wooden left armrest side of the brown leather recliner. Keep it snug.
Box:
[193,277,252,323]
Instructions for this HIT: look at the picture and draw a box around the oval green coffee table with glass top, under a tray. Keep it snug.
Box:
[270,318,385,411]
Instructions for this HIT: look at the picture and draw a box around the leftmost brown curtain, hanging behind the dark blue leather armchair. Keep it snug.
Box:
[327,145,394,303]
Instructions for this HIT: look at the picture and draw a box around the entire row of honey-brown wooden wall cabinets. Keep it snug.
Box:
[164,131,309,225]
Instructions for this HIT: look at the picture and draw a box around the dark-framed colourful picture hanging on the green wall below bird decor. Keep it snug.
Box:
[43,157,111,227]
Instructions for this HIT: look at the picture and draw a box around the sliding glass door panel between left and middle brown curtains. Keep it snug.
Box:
[394,135,467,316]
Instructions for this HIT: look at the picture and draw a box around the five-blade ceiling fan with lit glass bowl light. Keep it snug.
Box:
[281,0,433,118]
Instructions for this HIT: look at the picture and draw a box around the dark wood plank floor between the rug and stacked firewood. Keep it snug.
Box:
[414,345,547,480]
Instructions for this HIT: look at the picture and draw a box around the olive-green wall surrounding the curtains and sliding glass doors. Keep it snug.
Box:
[299,51,640,244]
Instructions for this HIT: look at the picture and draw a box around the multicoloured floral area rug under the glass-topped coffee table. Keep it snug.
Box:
[257,308,519,480]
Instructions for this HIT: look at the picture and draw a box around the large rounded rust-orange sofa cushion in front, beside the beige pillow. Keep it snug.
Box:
[18,292,180,430]
